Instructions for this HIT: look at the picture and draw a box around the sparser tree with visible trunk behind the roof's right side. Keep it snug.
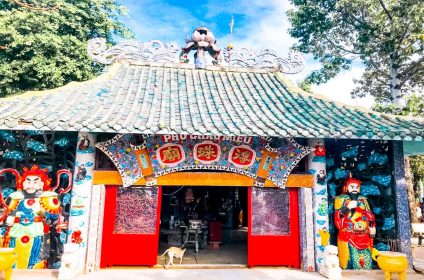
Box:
[288,0,424,106]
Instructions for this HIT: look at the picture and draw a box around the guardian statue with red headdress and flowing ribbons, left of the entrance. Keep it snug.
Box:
[0,165,72,268]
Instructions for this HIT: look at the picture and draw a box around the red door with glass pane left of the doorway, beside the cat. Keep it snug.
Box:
[100,186,162,268]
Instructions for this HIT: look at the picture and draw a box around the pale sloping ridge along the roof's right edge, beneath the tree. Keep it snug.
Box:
[275,72,424,123]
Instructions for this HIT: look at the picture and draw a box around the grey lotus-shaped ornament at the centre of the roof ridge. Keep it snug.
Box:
[180,27,221,69]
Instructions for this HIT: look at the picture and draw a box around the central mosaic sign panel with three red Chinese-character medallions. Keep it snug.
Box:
[146,135,268,177]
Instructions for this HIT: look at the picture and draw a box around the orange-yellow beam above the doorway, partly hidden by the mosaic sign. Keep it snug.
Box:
[93,170,314,187]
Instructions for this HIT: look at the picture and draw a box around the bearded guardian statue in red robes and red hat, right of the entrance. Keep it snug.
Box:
[334,178,375,269]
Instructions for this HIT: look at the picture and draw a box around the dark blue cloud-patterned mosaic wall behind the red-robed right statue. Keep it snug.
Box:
[325,140,398,254]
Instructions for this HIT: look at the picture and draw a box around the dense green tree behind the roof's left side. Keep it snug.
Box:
[0,0,132,97]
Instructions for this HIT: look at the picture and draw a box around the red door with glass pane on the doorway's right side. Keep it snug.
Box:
[247,188,300,268]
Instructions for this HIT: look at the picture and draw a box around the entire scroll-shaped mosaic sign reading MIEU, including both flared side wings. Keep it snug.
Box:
[96,134,313,188]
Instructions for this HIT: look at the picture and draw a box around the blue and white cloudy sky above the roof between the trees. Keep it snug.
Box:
[118,0,372,107]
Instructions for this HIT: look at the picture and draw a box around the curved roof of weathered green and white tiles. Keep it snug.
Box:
[0,63,424,141]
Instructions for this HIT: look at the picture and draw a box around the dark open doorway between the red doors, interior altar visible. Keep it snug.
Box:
[158,186,248,265]
